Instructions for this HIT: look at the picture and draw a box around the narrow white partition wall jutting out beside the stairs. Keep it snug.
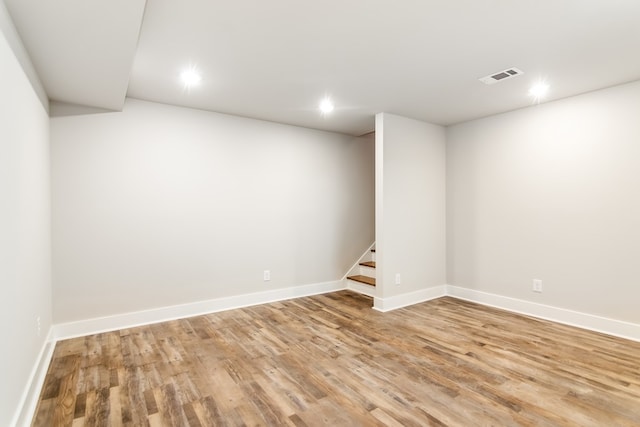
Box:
[375,113,446,309]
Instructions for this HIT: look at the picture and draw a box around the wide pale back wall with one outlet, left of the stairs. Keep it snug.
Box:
[51,99,374,323]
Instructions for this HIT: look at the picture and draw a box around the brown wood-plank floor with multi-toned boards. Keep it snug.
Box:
[33,291,640,426]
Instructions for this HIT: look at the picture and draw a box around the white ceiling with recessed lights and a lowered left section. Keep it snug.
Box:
[4,0,640,135]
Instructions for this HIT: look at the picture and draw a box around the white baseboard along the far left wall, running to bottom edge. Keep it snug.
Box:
[10,328,55,427]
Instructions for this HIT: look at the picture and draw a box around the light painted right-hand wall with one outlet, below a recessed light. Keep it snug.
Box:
[447,82,640,323]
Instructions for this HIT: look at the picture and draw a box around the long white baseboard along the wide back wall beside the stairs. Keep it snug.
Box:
[53,280,346,341]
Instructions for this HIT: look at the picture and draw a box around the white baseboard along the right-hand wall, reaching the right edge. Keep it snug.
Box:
[446,285,640,342]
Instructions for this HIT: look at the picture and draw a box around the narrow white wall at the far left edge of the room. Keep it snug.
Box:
[0,8,51,426]
